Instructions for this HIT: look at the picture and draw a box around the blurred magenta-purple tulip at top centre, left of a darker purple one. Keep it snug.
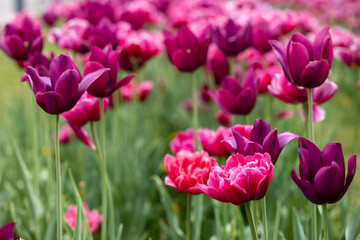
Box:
[163,25,210,72]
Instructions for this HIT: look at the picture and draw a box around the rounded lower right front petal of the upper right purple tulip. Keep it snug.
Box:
[299,59,330,88]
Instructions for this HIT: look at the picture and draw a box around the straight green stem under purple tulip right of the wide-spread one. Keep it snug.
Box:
[99,98,108,240]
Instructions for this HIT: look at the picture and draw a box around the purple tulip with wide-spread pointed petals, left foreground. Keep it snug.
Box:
[25,54,109,114]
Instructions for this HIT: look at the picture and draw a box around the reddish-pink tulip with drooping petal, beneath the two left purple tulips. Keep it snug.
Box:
[60,92,109,150]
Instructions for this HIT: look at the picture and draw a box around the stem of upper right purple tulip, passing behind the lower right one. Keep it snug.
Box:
[307,88,317,239]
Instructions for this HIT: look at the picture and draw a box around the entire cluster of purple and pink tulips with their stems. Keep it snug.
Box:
[0,0,360,240]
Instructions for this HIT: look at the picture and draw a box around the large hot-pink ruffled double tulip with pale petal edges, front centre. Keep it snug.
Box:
[198,153,274,205]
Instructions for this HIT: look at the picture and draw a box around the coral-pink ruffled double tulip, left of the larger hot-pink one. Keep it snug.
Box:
[164,150,216,194]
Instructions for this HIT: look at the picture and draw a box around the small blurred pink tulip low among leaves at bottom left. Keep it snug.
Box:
[65,203,103,234]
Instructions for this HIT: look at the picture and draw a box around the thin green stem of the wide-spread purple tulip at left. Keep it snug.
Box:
[55,115,62,240]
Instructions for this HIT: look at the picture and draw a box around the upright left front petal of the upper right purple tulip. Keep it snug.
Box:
[287,42,310,85]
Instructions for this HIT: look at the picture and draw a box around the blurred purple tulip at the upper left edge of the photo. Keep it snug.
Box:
[0,13,43,62]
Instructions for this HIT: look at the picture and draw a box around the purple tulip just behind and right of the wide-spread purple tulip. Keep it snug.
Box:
[84,45,135,98]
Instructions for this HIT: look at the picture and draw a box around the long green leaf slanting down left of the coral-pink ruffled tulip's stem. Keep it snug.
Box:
[152,176,184,239]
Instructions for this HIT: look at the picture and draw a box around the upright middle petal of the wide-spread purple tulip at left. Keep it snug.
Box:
[55,69,81,106]
